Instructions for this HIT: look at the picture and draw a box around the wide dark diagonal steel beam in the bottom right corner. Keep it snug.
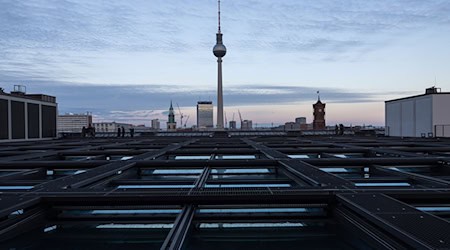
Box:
[337,194,450,249]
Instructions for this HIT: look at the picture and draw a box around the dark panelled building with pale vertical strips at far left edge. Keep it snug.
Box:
[0,85,58,141]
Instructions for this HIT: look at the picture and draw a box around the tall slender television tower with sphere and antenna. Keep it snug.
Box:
[213,0,227,130]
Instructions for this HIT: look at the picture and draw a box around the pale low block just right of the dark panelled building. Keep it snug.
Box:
[58,113,92,133]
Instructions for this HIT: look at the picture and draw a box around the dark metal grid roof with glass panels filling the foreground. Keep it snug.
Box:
[0,133,450,249]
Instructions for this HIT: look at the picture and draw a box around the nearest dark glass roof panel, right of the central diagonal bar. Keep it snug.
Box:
[183,219,370,250]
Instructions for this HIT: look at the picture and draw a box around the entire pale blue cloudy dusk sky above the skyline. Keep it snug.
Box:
[0,0,450,128]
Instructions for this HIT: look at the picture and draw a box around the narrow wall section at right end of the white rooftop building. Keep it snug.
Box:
[432,94,450,137]
